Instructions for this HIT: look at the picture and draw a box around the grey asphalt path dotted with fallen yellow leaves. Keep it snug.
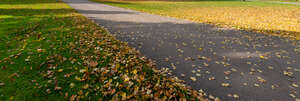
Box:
[64,0,300,101]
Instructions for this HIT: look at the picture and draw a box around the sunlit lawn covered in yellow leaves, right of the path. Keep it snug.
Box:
[92,0,300,39]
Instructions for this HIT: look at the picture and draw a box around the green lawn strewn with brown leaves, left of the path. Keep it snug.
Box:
[0,0,206,101]
